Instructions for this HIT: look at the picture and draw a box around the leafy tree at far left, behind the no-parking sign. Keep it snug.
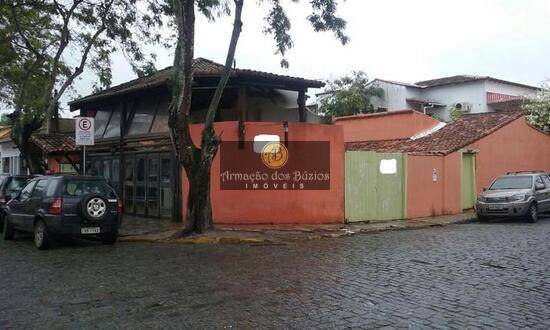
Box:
[0,0,168,173]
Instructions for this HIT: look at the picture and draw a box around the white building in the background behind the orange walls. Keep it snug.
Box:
[370,75,539,121]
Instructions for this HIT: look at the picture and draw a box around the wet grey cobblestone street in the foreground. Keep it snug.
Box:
[0,219,550,329]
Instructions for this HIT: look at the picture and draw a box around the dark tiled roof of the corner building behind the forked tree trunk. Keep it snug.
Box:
[69,57,325,109]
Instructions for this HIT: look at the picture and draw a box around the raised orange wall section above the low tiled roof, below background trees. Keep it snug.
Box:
[334,110,439,142]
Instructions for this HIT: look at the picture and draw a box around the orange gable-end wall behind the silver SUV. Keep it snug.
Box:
[468,117,550,192]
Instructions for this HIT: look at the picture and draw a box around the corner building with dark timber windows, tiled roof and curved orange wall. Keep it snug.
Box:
[69,58,343,223]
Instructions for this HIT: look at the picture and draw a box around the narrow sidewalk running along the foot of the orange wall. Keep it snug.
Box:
[119,212,475,244]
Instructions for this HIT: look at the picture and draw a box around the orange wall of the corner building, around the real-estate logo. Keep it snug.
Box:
[182,122,344,224]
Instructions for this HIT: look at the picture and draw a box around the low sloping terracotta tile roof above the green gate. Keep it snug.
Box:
[346,111,524,155]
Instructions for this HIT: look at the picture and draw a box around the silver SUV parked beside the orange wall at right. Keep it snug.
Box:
[476,172,550,222]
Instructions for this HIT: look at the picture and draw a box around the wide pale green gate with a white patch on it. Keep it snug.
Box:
[345,151,407,222]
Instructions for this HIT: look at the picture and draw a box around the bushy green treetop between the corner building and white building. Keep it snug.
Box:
[320,71,384,117]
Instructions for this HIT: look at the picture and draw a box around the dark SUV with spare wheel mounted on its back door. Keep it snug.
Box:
[2,175,122,249]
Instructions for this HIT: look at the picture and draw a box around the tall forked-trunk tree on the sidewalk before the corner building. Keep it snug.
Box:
[169,0,348,232]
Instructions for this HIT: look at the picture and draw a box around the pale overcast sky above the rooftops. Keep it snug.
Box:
[66,0,550,114]
